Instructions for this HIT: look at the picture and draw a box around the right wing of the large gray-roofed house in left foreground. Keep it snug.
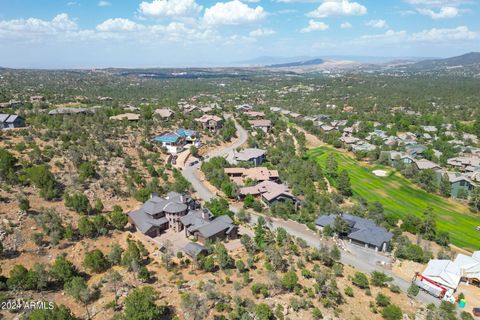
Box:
[180,208,238,244]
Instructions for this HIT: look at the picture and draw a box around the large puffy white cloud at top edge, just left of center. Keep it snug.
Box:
[203,0,267,25]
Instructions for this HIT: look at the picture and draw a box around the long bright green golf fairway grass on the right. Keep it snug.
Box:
[308,147,480,251]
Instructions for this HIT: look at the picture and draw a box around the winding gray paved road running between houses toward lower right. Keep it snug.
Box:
[182,122,440,305]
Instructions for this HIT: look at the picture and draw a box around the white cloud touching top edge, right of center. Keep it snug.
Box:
[307,0,368,18]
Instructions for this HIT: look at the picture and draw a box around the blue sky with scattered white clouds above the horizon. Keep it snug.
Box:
[0,0,480,68]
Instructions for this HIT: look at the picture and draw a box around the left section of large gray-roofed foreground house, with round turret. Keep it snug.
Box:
[128,192,198,237]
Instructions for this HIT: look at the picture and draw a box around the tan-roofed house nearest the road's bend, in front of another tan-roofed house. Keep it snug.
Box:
[239,181,297,206]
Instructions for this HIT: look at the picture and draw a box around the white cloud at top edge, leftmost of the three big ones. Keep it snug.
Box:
[139,0,203,18]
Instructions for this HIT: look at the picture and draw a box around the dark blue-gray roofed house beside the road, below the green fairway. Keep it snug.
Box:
[315,213,393,251]
